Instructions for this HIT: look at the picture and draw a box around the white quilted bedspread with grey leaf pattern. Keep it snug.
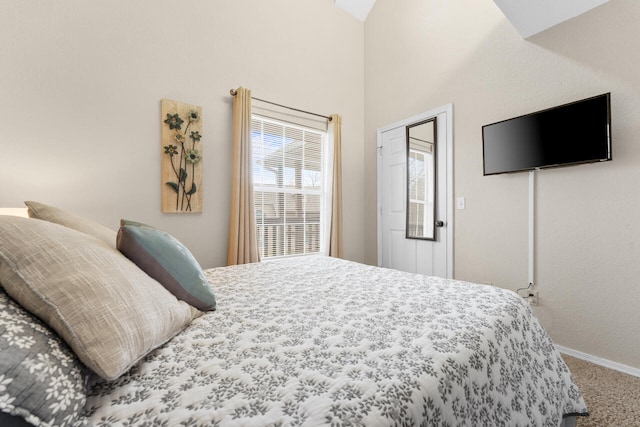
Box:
[80,257,587,426]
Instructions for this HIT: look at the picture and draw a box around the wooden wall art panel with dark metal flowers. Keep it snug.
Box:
[162,99,202,213]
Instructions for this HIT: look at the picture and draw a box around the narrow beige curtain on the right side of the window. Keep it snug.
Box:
[328,114,342,258]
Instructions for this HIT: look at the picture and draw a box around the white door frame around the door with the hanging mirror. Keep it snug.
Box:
[376,103,454,279]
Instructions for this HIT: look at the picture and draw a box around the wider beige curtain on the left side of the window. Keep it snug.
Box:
[227,88,260,265]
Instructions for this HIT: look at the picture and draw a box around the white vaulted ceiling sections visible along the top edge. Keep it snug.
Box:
[334,0,609,39]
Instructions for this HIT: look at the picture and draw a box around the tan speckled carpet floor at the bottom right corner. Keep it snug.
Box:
[562,354,640,427]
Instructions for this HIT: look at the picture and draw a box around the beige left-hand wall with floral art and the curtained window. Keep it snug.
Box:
[0,0,364,267]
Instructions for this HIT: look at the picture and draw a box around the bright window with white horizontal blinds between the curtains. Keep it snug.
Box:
[251,115,327,259]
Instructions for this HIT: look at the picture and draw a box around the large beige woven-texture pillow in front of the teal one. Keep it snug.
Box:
[0,216,200,380]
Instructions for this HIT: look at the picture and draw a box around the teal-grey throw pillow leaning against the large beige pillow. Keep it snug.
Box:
[116,219,216,311]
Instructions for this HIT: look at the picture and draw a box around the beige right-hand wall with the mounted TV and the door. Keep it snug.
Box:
[365,0,640,368]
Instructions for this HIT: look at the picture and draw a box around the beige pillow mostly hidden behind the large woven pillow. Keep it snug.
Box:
[24,201,116,247]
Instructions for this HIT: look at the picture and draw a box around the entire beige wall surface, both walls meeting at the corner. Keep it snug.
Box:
[0,0,640,367]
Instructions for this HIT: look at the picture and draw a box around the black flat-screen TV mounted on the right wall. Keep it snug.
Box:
[482,93,611,175]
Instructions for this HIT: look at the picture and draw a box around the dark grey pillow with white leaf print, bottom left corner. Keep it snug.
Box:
[0,288,89,426]
